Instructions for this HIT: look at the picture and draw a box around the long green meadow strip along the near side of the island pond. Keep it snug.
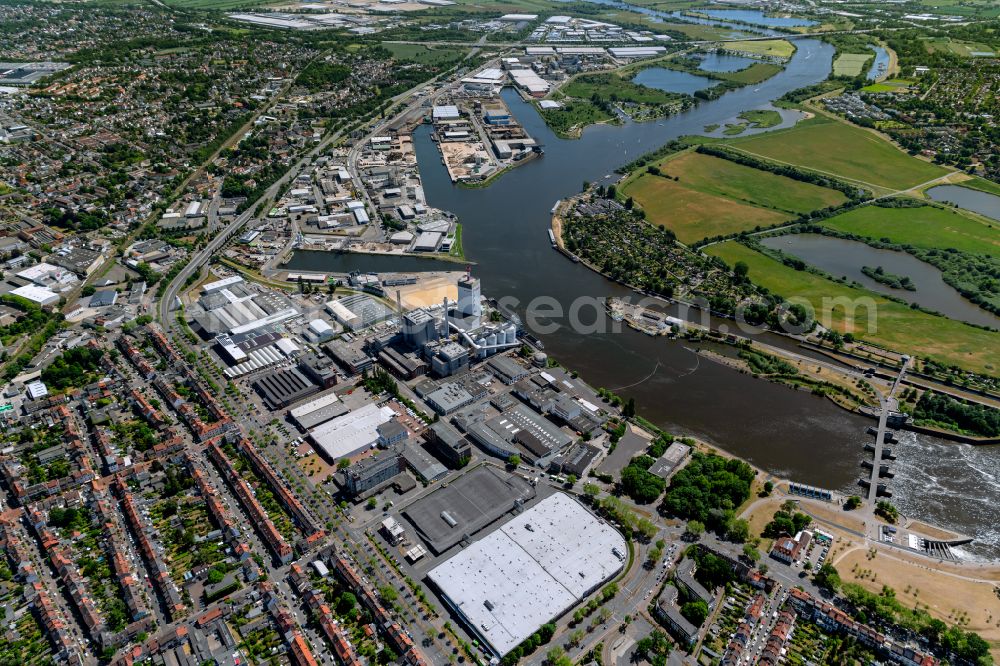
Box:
[706,241,1000,373]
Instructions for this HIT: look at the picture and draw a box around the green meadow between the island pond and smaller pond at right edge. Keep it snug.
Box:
[822,206,1000,257]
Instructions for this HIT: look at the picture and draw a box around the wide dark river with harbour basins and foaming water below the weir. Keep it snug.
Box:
[289,39,1000,557]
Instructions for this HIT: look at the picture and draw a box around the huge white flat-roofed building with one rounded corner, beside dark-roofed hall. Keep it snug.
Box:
[428,493,628,656]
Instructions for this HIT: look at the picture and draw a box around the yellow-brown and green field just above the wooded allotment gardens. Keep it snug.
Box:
[622,152,846,243]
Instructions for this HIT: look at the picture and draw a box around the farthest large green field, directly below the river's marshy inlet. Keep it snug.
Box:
[731,117,948,190]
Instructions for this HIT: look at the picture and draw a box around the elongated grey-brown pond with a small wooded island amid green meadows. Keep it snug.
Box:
[762,234,1000,328]
